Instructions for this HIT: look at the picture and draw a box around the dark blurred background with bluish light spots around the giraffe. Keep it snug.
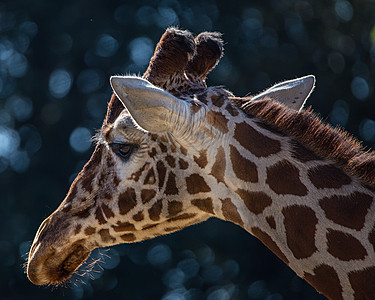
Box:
[0,0,375,300]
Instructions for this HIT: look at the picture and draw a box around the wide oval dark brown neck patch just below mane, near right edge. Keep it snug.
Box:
[307,165,352,189]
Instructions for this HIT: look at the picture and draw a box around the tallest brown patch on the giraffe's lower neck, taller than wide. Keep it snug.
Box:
[282,205,318,259]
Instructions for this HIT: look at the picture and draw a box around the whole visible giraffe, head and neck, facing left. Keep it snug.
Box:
[27,28,375,299]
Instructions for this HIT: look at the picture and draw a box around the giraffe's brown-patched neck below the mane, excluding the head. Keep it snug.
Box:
[206,101,375,299]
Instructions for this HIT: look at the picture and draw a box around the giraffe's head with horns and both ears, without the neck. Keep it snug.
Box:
[27,28,314,284]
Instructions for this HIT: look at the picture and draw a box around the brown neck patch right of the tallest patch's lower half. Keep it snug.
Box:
[327,229,367,261]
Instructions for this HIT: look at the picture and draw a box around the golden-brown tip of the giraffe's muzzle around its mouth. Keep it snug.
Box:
[27,242,91,285]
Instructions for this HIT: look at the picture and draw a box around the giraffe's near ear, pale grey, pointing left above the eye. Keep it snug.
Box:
[111,76,189,133]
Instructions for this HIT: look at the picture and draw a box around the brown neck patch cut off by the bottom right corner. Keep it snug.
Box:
[349,267,375,299]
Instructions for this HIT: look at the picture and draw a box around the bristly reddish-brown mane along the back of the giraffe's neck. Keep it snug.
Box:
[235,98,375,187]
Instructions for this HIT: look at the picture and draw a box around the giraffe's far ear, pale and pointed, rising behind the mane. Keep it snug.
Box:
[252,75,315,110]
